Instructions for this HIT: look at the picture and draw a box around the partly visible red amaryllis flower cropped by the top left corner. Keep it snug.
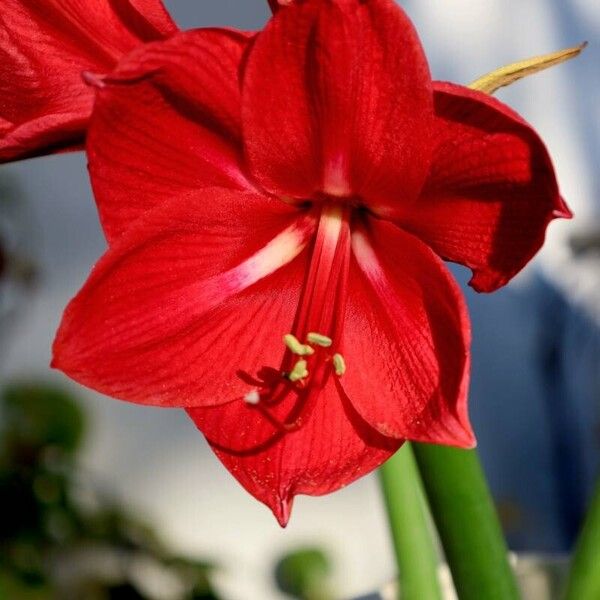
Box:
[0,0,177,162]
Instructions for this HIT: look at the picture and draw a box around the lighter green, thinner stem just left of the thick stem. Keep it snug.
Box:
[379,443,442,600]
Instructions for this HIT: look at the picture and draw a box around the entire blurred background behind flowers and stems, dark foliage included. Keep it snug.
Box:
[0,0,600,600]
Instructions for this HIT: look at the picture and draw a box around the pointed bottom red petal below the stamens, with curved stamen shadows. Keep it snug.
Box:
[188,378,402,526]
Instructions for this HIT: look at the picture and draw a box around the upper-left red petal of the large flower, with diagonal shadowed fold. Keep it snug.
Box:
[87,29,251,240]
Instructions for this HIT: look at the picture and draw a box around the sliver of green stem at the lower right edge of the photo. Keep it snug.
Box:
[565,481,600,600]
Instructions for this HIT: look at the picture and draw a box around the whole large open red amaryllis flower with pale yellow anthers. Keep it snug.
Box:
[54,0,568,524]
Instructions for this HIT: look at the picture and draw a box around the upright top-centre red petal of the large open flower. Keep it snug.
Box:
[243,0,432,205]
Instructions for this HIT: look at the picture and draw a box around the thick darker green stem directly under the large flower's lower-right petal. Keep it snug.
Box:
[414,444,520,600]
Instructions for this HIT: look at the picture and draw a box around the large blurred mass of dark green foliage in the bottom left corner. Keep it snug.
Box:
[0,384,218,600]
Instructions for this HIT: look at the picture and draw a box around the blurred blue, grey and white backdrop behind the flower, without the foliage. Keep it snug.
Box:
[0,0,600,600]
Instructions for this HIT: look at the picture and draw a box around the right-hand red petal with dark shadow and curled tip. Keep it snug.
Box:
[400,83,570,292]
